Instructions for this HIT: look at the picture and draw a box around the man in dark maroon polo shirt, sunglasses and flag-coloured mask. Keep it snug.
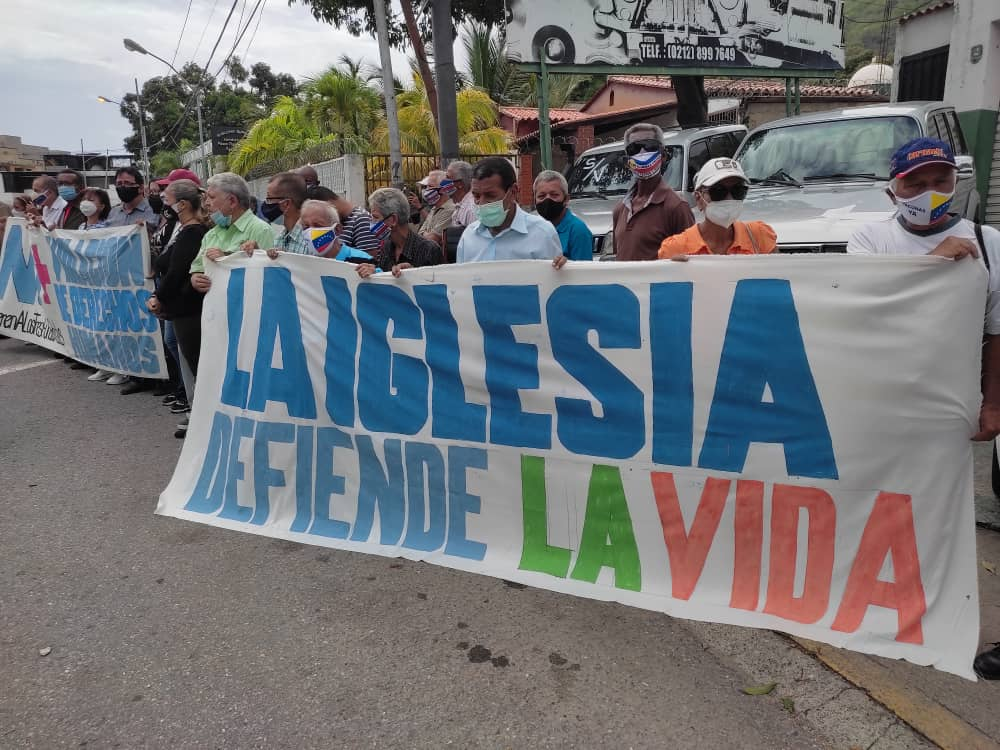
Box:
[612,122,694,260]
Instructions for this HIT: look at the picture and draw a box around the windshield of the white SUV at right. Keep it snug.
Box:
[736,117,920,185]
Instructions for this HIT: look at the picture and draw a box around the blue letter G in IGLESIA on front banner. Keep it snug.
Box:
[357,284,428,435]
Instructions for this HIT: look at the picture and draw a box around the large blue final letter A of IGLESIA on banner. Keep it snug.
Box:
[698,279,838,479]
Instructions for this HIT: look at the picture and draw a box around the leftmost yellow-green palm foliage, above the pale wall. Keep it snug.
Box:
[229,96,335,175]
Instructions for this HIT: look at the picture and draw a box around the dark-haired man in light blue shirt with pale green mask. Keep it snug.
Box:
[456,156,562,263]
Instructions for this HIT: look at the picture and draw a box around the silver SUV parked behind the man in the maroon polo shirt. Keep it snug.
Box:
[566,120,747,259]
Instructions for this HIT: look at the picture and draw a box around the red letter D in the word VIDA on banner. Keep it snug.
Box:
[764,484,837,623]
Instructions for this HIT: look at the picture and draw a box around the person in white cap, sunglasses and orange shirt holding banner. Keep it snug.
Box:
[659,158,777,260]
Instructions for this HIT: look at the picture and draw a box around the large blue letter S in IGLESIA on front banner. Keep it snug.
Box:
[545,284,646,458]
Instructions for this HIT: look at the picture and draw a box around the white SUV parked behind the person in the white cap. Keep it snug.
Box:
[736,102,980,252]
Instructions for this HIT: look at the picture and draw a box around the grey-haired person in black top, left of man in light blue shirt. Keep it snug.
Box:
[358,188,444,279]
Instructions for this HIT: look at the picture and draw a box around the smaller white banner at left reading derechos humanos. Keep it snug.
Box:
[0,219,167,378]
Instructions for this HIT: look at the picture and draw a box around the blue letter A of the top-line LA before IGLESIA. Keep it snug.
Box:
[246,268,316,419]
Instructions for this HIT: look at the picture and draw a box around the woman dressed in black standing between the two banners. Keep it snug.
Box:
[146,180,208,437]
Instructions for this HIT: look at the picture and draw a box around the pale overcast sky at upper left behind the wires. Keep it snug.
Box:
[0,0,409,152]
